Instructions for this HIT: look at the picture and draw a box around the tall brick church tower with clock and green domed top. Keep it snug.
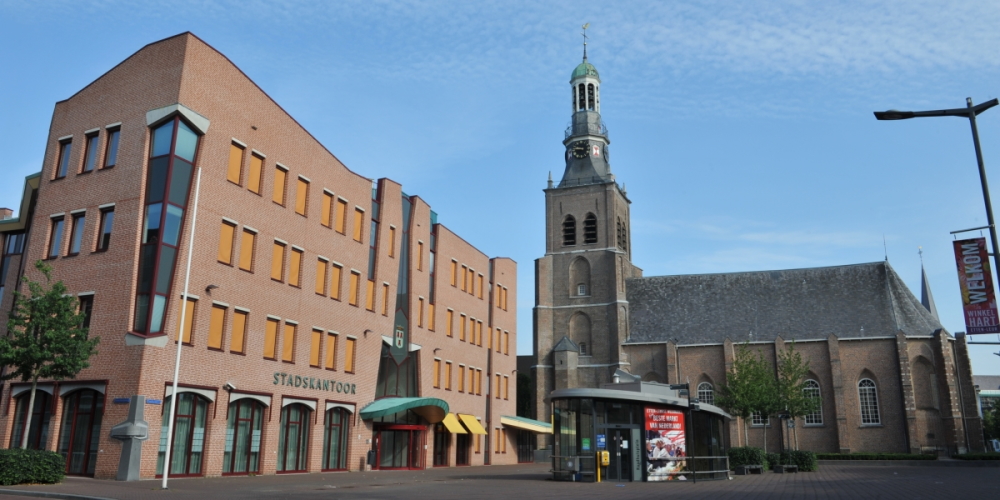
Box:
[532,43,641,428]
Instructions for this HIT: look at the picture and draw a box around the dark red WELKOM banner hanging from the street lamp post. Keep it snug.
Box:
[954,238,1000,334]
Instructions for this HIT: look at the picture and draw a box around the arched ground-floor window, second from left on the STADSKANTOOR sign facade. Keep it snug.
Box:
[222,398,264,474]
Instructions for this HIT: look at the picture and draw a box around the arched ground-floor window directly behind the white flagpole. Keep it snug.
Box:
[156,392,208,477]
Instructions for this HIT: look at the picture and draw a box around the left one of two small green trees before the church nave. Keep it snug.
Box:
[717,343,778,451]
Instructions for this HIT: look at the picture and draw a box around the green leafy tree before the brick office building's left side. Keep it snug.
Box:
[0,261,100,448]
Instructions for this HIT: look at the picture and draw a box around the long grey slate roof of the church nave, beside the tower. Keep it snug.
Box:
[626,262,943,344]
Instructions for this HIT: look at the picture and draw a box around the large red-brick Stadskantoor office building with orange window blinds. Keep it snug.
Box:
[0,33,516,478]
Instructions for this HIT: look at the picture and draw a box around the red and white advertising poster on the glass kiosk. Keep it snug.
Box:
[646,407,687,481]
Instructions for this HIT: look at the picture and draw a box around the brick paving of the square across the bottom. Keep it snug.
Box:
[0,464,1000,500]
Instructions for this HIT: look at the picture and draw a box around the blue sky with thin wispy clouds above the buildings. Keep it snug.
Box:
[0,0,1000,375]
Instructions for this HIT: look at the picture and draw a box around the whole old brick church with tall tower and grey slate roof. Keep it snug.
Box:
[531,55,983,453]
